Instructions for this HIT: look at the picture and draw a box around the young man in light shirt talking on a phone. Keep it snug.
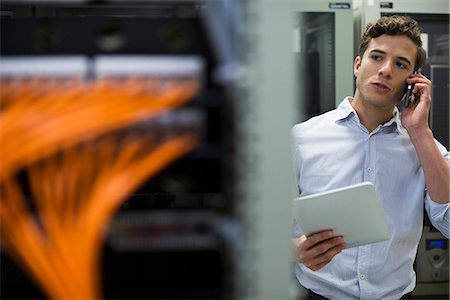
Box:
[293,16,450,299]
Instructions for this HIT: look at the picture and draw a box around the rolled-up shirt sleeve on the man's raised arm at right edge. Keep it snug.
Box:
[425,141,450,238]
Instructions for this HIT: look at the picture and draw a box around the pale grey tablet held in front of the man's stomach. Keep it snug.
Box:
[293,182,391,248]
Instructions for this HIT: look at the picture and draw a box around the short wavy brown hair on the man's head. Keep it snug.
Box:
[359,15,427,70]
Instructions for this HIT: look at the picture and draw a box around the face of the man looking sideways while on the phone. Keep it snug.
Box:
[353,34,417,109]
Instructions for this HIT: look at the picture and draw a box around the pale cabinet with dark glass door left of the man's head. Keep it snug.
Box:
[293,0,354,121]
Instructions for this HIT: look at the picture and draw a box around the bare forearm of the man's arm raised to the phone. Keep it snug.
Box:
[408,128,450,204]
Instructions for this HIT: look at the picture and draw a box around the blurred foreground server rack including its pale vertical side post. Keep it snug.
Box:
[1,0,295,299]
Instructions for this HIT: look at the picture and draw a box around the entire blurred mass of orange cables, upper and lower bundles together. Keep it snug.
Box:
[0,71,198,299]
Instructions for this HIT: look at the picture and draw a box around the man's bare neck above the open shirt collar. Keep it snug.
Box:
[351,94,394,132]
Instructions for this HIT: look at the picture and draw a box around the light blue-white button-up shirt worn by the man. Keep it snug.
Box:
[292,97,450,299]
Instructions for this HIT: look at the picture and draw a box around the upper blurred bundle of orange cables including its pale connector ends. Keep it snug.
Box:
[0,78,197,178]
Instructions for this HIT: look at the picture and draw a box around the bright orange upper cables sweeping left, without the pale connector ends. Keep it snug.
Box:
[0,80,198,178]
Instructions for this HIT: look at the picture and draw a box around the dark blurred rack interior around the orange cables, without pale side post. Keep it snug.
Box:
[1,1,236,299]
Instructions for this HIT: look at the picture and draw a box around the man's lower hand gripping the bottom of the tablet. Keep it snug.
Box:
[292,230,346,271]
